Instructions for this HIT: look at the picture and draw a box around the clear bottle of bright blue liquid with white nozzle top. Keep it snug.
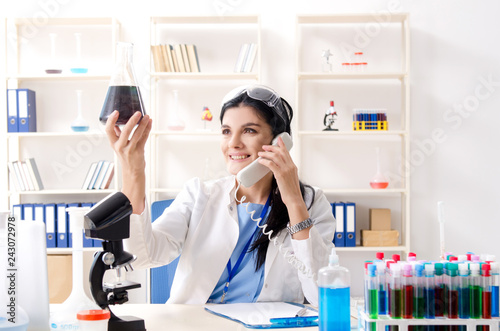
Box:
[318,248,351,331]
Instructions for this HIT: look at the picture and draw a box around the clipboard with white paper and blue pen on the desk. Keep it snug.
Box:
[204,302,318,329]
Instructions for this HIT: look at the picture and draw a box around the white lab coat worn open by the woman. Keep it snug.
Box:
[125,176,335,306]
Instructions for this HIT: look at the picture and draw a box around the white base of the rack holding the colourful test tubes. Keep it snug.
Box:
[359,310,500,331]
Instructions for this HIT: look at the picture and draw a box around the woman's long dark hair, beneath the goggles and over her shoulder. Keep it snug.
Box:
[220,93,314,271]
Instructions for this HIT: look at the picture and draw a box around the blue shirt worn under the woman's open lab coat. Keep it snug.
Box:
[208,203,271,303]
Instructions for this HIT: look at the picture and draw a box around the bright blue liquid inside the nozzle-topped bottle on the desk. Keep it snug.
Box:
[319,287,351,331]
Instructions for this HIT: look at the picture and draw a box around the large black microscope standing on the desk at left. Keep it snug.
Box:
[84,192,146,331]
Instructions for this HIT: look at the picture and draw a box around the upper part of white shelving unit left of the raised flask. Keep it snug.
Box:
[2,18,120,209]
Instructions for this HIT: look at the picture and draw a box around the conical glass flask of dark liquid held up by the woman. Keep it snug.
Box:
[99,42,146,125]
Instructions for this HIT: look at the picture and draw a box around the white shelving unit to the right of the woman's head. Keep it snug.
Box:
[293,14,410,252]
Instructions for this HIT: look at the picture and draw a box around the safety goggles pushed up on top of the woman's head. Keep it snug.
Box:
[222,85,290,129]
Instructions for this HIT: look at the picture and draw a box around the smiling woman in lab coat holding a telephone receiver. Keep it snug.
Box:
[106,85,335,305]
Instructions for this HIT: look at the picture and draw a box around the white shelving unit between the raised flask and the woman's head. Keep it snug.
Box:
[147,16,262,202]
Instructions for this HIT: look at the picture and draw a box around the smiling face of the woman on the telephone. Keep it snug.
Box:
[221,105,273,175]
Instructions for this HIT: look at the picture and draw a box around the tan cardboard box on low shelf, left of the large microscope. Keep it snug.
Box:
[47,254,73,303]
